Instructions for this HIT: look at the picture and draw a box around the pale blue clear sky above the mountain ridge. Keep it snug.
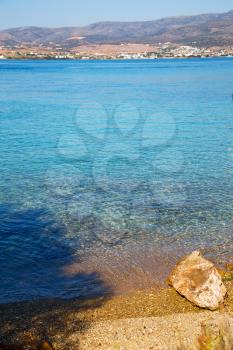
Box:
[0,0,233,29]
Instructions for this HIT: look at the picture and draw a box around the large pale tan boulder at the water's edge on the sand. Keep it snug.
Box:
[168,251,226,310]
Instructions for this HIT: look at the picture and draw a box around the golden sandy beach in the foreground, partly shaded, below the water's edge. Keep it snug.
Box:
[0,282,233,350]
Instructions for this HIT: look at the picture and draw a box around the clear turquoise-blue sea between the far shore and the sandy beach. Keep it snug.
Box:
[0,58,233,302]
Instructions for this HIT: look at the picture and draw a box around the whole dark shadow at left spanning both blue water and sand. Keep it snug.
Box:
[0,207,113,350]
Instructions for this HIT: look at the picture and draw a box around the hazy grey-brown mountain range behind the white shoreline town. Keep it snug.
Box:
[0,10,233,49]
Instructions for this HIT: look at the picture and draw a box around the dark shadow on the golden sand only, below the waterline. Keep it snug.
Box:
[0,273,111,350]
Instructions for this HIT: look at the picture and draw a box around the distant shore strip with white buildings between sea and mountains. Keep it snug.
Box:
[0,42,233,60]
